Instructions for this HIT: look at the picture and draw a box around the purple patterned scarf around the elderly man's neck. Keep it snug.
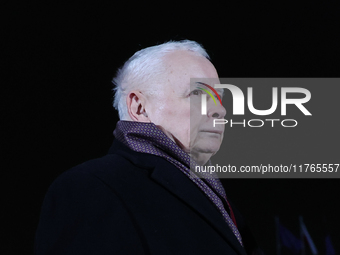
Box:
[113,121,243,246]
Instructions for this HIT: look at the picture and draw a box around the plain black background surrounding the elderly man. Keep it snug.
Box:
[0,1,340,254]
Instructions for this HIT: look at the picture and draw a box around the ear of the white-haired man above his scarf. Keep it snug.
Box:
[126,90,150,122]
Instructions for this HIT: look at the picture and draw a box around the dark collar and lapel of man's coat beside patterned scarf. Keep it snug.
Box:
[109,140,246,255]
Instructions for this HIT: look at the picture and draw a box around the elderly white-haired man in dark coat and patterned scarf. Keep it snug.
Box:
[35,40,256,255]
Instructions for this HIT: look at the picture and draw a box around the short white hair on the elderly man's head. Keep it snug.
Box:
[112,40,209,120]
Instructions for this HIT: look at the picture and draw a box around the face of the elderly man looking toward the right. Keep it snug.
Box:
[145,51,226,164]
